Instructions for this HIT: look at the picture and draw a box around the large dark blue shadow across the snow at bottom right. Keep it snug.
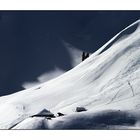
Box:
[52,111,137,130]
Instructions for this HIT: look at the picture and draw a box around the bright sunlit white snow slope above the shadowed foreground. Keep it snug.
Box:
[0,20,140,129]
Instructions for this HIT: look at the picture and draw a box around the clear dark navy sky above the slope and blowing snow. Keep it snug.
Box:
[0,11,140,96]
